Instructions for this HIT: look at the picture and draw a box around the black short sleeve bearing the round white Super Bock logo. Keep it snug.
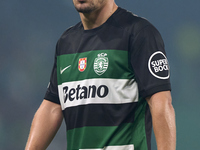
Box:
[130,24,171,98]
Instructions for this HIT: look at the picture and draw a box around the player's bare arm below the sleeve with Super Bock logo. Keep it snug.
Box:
[147,91,176,150]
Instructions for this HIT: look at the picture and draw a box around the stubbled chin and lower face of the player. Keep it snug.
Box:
[73,0,106,13]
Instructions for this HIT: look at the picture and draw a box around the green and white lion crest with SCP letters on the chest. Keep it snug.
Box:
[94,53,108,76]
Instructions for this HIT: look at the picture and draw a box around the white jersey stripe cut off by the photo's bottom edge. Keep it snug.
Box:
[79,144,134,150]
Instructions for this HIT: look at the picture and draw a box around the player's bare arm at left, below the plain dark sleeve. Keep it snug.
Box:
[25,100,63,150]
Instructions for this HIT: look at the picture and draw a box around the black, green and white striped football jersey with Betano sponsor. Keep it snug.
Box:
[45,8,171,150]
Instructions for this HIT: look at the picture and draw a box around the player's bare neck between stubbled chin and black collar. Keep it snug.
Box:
[79,3,118,30]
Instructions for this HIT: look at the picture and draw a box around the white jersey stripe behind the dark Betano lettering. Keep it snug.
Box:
[58,79,139,110]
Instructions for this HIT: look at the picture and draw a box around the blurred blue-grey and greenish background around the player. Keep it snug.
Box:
[0,0,200,150]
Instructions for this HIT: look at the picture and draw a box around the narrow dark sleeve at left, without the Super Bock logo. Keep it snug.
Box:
[44,44,60,104]
